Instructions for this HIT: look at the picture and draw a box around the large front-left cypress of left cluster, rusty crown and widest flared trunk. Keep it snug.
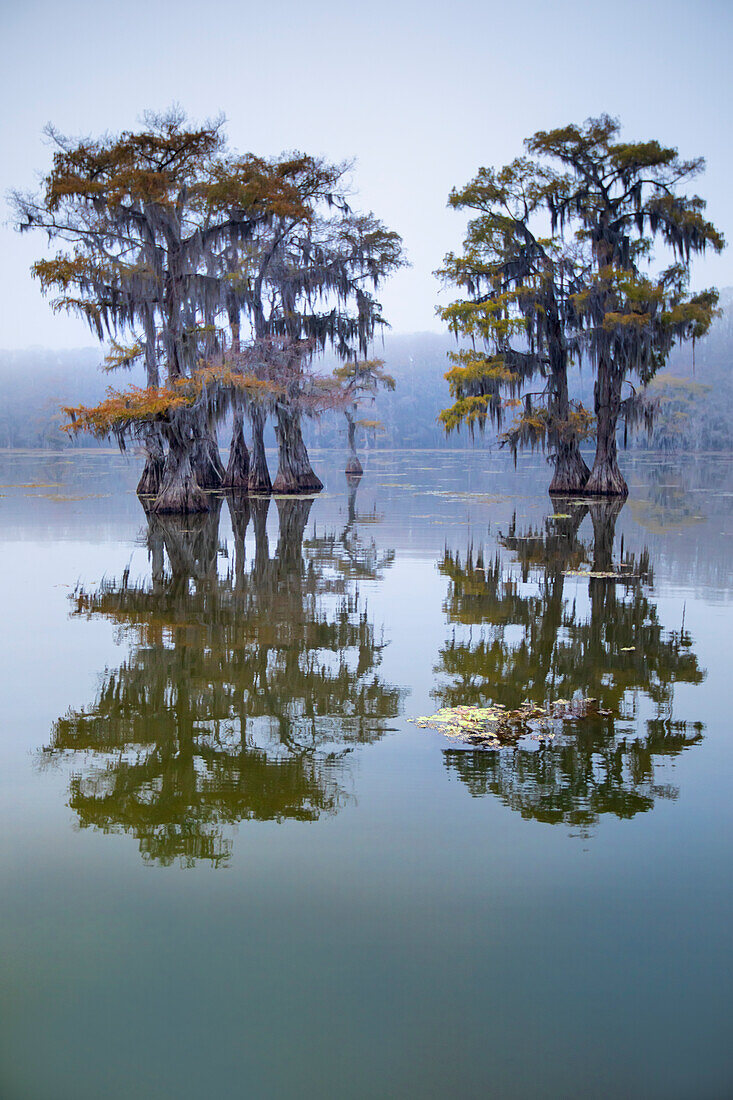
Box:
[14,110,323,512]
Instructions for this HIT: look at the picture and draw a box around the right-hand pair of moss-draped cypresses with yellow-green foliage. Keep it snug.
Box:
[439,116,724,496]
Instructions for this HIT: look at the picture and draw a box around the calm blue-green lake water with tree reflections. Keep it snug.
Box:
[0,449,733,1100]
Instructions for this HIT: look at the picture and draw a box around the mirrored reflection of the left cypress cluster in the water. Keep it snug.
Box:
[44,498,401,865]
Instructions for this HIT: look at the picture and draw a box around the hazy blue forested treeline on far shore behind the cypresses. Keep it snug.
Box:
[0,288,733,451]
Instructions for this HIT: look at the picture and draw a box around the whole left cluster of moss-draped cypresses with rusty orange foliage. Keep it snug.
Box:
[14,109,403,512]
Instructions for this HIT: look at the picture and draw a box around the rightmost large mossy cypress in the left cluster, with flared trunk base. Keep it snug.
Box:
[225,191,404,493]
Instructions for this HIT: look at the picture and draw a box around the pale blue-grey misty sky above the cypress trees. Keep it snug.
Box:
[0,0,733,348]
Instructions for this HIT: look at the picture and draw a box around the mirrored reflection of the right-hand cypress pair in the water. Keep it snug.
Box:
[434,501,704,832]
